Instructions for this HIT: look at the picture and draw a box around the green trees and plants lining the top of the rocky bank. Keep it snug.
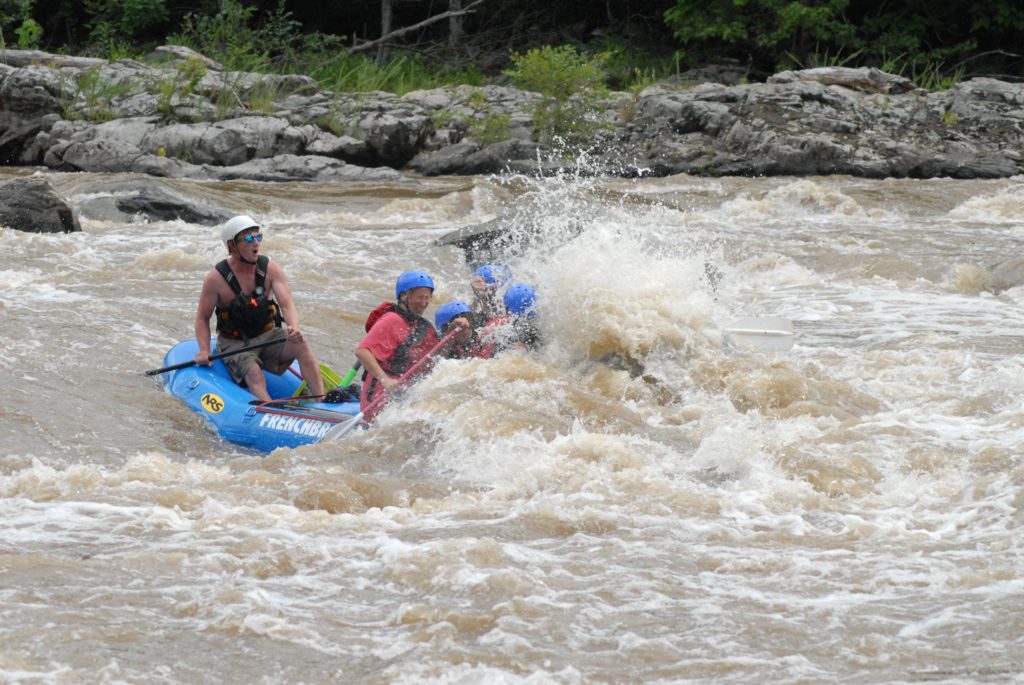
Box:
[0,0,1024,94]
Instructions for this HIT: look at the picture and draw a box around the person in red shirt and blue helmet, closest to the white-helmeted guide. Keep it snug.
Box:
[355,271,460,413]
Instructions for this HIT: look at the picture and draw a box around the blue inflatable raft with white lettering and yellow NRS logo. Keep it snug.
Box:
[154,340,359,452]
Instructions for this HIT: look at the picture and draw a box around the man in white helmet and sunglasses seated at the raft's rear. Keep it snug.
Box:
[196,215,324,401]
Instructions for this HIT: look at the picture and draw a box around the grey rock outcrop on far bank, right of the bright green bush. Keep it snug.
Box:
[604,70,1024,178]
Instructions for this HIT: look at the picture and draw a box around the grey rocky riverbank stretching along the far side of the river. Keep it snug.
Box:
[0,47,1024,181]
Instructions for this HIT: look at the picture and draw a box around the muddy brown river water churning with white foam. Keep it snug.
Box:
[6,177,1024,683]
